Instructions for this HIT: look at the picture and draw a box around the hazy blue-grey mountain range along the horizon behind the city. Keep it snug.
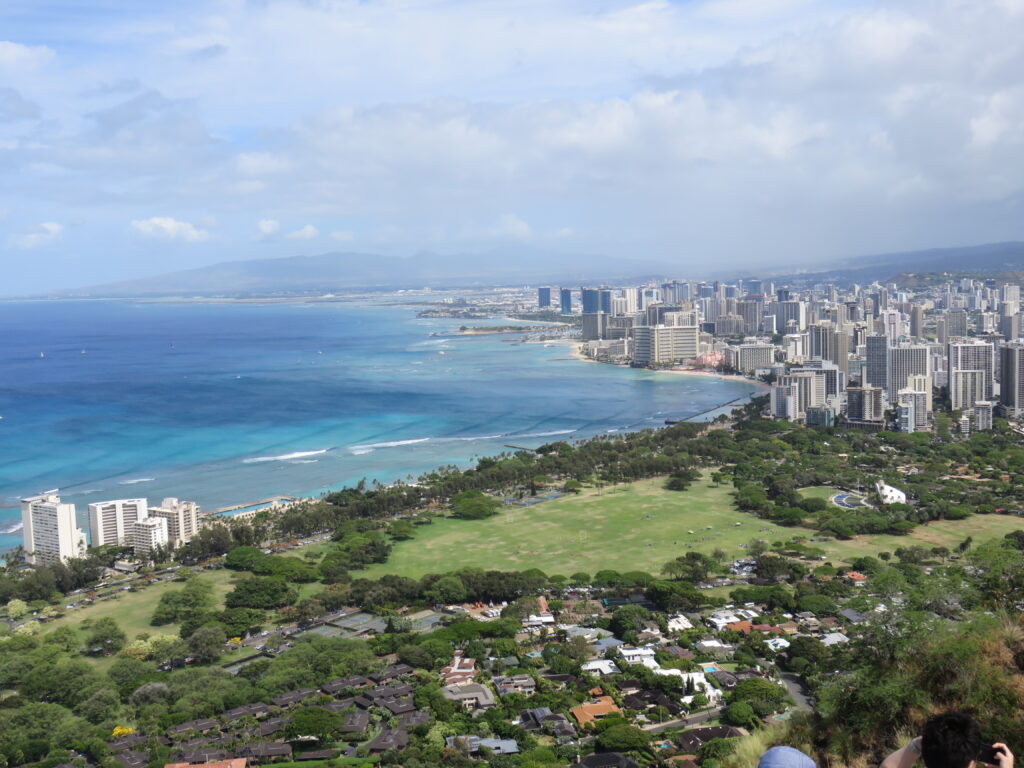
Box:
[39,243,1024,298]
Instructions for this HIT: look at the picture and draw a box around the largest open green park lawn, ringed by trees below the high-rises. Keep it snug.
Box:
[359,474,1024,578]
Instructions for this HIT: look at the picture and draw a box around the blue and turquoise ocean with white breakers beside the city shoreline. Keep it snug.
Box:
[0,301,754,550]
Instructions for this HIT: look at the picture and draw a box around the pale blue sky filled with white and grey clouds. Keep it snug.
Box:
[0,0,1024,295]
